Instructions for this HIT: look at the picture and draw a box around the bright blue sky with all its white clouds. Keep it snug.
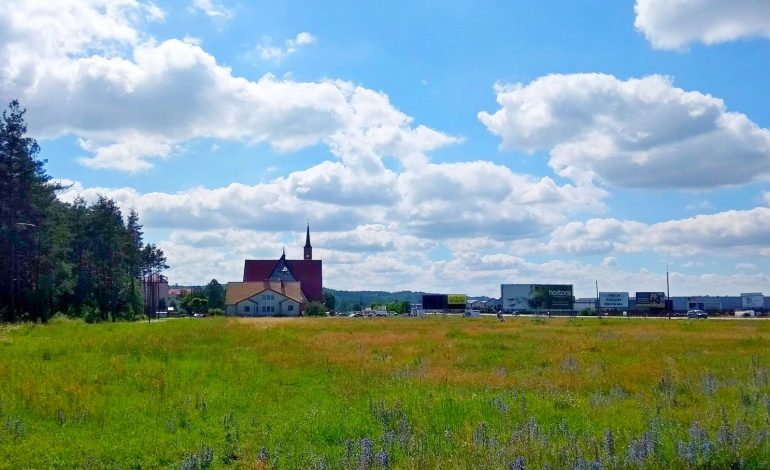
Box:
[0,0,770,297]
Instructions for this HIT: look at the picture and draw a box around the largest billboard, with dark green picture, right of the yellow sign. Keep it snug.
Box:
[500,284,575,312]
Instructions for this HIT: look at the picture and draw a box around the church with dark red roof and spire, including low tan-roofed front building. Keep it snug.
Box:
[225,224,324,316]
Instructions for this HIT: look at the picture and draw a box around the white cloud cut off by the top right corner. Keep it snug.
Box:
[634,0,770,49]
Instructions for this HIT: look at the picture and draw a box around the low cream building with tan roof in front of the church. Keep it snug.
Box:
[225,281,305,317]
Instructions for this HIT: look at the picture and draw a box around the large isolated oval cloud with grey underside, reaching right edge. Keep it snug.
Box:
[478,73,770,188]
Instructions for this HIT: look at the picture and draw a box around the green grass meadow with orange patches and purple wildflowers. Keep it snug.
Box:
[0,318,770,469]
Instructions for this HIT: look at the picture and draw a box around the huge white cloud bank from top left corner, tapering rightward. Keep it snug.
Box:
[0,0,458,172]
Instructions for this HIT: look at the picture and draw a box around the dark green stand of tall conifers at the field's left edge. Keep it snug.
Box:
[0,100,168,322]
